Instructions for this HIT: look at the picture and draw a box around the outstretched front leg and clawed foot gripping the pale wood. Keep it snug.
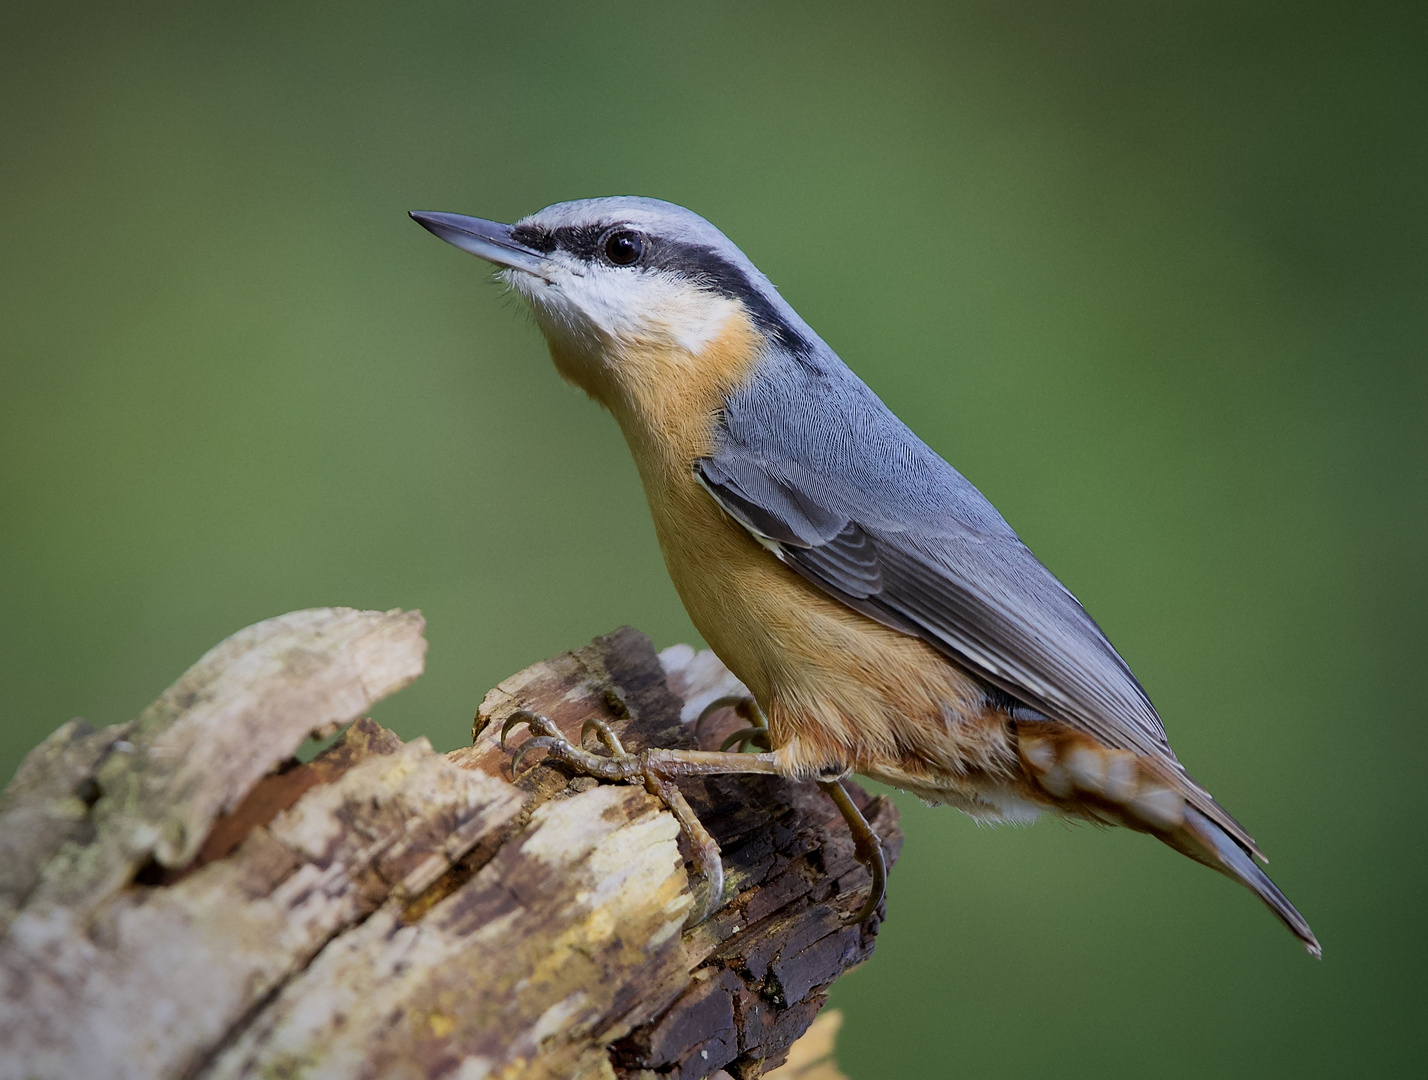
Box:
[501,709,778,926]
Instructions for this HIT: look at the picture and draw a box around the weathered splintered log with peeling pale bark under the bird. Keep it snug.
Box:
[0,609,901,1080]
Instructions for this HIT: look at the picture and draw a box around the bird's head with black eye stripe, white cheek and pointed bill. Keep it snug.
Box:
[411,197,811,407]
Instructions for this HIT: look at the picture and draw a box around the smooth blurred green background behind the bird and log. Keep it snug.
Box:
[0,0,1428,1080]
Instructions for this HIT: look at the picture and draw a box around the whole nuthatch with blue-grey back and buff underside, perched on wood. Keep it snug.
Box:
[410,196,1321,957]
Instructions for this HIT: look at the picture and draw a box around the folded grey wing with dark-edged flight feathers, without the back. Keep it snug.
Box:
[698,447,1172,757]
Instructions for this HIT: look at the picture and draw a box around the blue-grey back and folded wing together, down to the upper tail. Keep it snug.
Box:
[697,361,1257,851]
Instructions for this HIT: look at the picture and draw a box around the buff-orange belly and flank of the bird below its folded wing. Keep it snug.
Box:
[641,434,1035,820]
